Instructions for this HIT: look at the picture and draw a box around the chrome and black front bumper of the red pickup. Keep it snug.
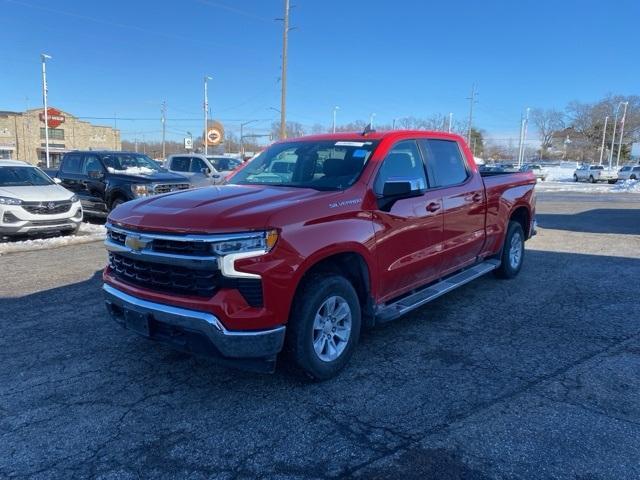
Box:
[102,284,285,361]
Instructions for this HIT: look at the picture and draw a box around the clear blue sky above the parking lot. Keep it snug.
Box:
[0,0,640,139]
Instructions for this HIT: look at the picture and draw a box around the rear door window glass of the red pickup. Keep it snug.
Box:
[420,139,469,187]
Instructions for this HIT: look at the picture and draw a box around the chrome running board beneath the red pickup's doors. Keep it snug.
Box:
[376,260,500,323]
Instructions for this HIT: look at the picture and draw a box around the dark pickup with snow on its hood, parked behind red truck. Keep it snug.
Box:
[47,151,191,217]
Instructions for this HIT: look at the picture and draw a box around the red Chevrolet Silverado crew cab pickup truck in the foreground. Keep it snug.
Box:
[103,131,536,380]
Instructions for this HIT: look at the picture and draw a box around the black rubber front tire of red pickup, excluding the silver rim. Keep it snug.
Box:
[286,274,362,381]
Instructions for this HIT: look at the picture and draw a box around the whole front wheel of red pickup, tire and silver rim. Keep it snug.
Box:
[287,275,361,380]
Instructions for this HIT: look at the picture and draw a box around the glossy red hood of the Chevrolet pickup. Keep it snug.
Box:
[109,185,328,233]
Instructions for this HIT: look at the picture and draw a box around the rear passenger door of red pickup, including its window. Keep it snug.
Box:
[419,139,486,276]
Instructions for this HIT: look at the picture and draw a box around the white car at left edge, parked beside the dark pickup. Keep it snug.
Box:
[0,160,82,237]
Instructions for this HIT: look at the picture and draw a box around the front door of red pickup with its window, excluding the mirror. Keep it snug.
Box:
[373,140,443,302]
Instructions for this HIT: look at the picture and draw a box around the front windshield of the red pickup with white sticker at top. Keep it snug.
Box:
[229,140,377,190]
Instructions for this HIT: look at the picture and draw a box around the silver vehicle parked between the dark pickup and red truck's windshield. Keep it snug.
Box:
[165,153,242,187]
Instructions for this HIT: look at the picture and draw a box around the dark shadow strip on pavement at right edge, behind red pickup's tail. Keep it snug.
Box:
[536,205,640,235]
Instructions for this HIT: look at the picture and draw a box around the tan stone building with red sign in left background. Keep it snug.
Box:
[0,108,121,167]
